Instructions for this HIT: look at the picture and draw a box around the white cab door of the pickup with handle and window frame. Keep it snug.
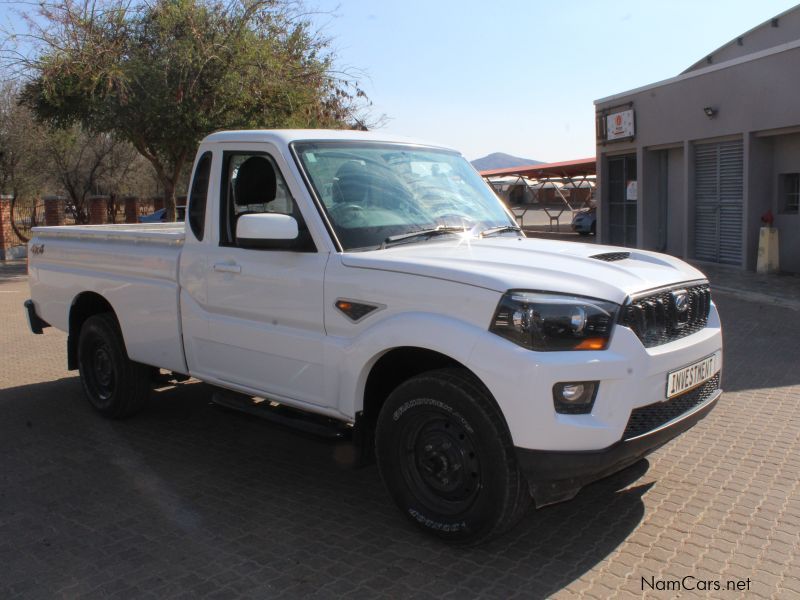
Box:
[198,144,328,406]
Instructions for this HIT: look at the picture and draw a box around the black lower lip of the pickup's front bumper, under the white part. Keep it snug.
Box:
[516,389,722,507]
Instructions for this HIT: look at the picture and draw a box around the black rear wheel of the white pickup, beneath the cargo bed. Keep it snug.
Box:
[78,313,151,419]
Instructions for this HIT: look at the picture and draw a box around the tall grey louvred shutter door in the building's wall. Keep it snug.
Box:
[694,140,744,265]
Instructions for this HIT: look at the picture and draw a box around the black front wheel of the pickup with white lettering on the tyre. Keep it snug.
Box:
[375,369,530,544]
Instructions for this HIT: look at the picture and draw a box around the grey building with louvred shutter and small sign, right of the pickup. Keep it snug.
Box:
[595,7,800,273]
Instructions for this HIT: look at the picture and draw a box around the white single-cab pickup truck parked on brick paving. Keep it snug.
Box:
[26,130,722,543]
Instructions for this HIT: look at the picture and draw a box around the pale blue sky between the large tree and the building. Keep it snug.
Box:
[307,0,796,162]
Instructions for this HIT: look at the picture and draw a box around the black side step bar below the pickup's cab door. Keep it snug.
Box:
[211,390,353,440]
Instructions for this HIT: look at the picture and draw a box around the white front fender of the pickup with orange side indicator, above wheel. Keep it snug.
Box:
[324,255,500,417]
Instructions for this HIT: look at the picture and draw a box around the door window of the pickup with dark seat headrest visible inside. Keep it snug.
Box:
[219,152,316,252]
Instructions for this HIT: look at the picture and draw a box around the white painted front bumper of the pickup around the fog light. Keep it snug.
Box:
[468,306,724,452]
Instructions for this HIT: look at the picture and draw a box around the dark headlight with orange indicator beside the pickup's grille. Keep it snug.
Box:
[489,291,619,351]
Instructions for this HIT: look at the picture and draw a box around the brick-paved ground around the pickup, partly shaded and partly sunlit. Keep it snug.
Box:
[0,258,800,599]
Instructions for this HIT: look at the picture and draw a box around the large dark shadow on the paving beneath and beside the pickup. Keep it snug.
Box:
[0,378,649,598]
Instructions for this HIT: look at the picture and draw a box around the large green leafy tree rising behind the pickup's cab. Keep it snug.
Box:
[12,0,366,218]
